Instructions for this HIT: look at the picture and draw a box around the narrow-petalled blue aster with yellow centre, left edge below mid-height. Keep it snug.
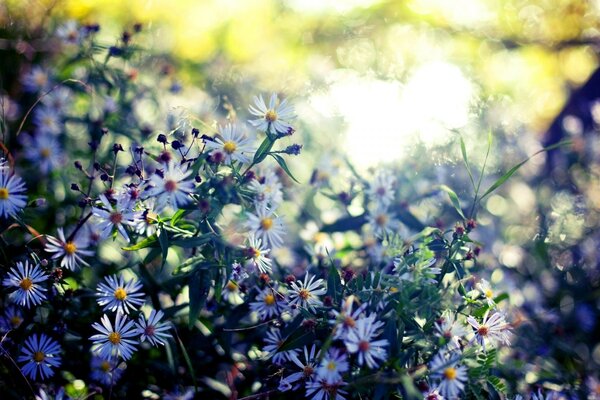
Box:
[2,261,48,308]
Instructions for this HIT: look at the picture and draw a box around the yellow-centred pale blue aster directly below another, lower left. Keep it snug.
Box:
[90,312,137,360]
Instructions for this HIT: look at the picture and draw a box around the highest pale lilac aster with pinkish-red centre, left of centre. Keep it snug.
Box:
[147,162,194,212]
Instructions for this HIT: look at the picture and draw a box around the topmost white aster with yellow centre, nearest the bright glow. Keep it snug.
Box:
[249,93,295,135]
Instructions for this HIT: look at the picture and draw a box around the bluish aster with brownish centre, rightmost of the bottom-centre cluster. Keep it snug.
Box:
[344,316,389,368]
